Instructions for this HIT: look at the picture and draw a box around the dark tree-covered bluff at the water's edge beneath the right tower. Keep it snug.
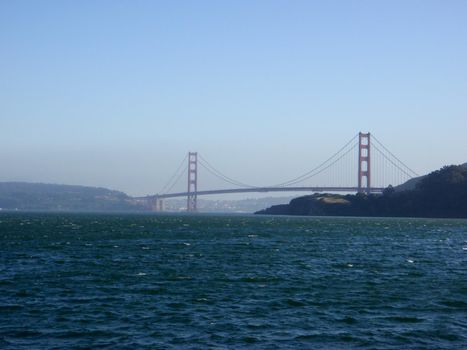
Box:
[255,164,467,218]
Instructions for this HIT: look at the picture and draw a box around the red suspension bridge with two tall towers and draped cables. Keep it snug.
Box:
[138,132,418,212]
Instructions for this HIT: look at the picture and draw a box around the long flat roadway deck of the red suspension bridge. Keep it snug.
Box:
[140,187,384,199]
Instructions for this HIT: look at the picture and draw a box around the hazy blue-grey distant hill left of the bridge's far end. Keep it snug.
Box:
[0,182,147,212]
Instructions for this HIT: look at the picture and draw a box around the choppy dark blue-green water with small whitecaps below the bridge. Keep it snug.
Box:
[0,213,467,350]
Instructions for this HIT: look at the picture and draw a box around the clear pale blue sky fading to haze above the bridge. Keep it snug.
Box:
[0,0,467,195]
